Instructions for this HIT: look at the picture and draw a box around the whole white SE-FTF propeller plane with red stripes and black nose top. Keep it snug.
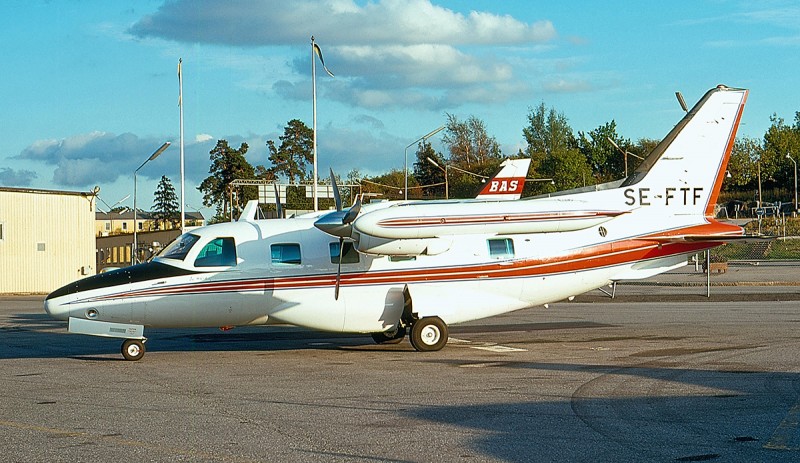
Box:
[44,85,748,360]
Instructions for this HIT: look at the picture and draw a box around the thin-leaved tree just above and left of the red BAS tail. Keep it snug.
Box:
[442,114,502,169]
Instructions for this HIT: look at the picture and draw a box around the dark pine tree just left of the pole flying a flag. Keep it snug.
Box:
[267,119,314,183]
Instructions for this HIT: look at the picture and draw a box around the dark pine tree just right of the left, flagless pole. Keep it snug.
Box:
[198,140,258,222]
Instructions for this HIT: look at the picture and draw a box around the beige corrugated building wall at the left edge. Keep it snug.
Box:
[0,189,95,293]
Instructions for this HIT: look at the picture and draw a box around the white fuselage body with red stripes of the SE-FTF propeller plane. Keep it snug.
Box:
[46,190,720,333]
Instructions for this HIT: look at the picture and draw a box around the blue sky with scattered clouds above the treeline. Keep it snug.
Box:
[0,0,800,216]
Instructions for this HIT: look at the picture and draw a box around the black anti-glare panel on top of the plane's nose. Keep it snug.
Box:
[47,262,199,299]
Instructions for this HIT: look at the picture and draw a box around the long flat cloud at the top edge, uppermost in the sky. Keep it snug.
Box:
[130,0,556,46]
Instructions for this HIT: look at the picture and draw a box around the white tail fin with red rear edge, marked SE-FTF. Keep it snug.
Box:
[620,85,748,216]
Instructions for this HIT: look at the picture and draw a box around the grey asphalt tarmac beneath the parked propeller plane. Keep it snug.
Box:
[0,268,800,462]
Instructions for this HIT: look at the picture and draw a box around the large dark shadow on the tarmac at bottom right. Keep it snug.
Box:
[403,361,800,462]
